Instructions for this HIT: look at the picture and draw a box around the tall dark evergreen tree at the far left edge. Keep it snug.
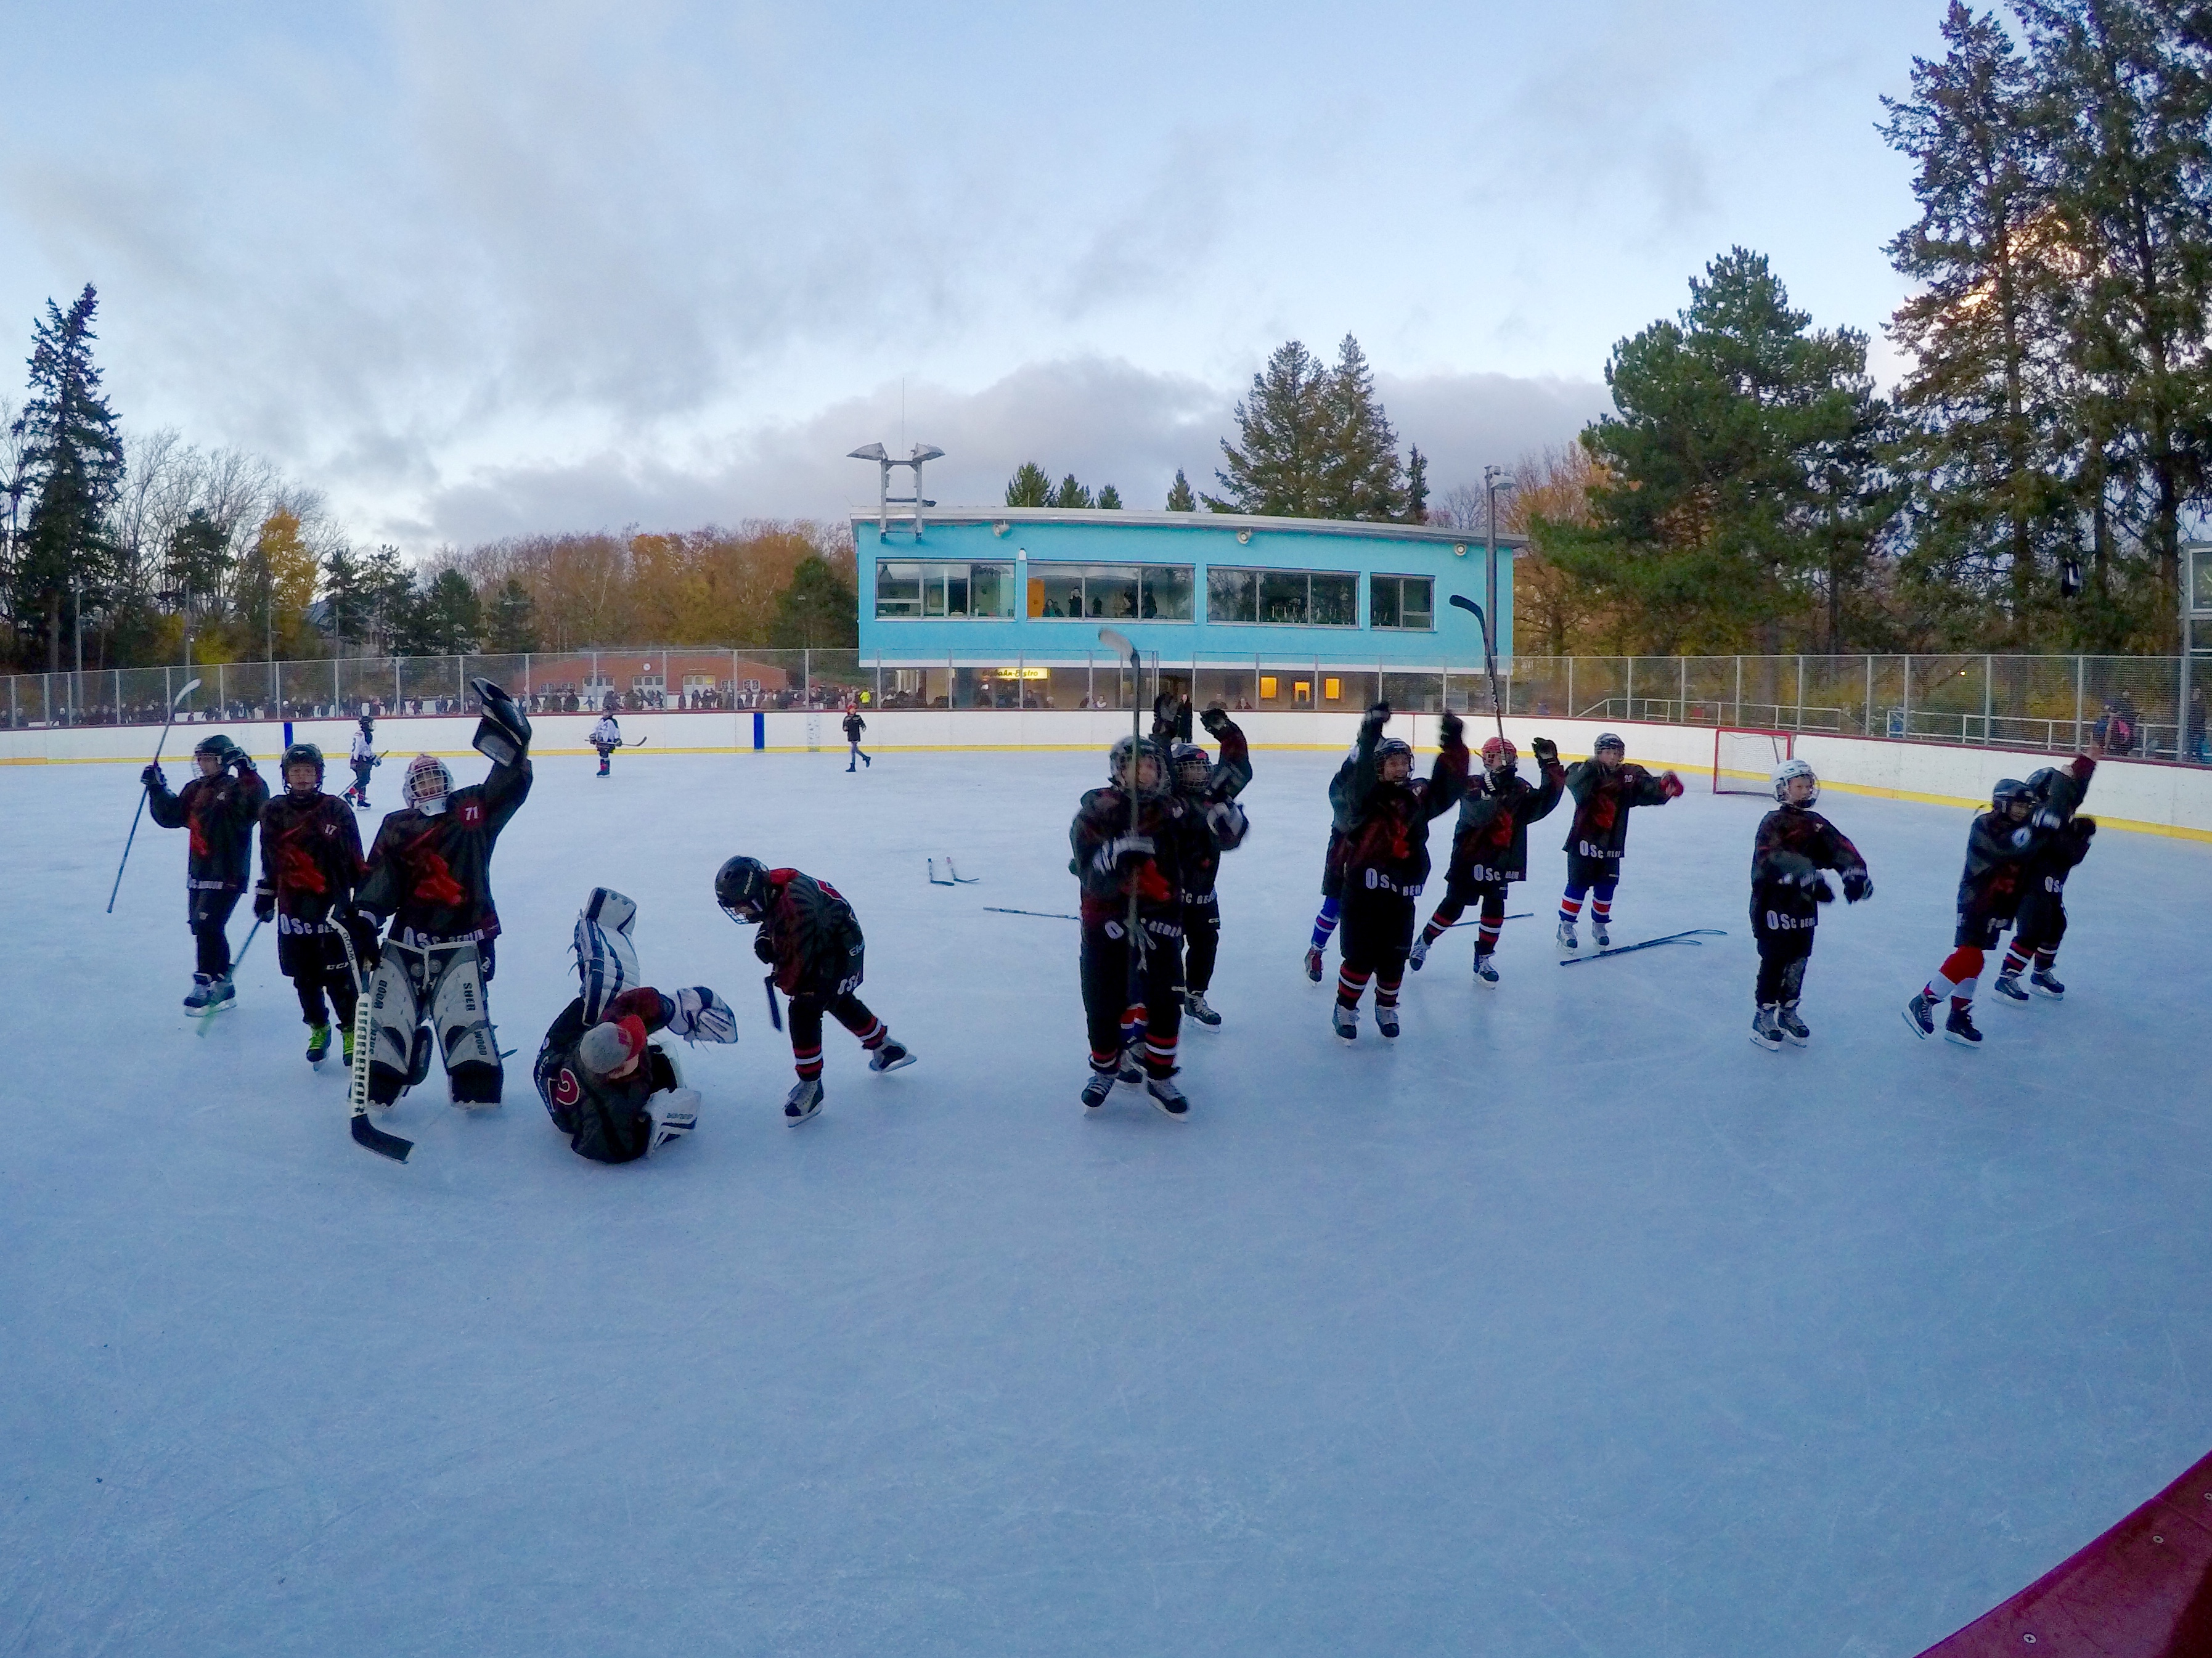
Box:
[11,283,124,672]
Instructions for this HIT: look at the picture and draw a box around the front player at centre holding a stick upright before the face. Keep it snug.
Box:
[1068,736,1190,1121]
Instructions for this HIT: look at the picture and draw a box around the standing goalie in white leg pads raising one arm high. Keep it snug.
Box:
[354,679,531,1105]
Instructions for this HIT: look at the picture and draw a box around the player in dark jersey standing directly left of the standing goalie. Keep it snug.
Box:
[255,743,363,1066]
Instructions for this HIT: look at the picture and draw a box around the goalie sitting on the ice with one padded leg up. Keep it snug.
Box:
[531,886,737,1163]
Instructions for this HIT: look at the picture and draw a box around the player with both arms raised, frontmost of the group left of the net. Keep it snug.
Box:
[1329,703,1469,1041]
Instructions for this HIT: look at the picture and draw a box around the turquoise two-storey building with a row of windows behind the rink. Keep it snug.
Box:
[852,506,1522,709]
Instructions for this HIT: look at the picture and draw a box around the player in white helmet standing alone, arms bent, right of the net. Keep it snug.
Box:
[1752,761,1874,1048]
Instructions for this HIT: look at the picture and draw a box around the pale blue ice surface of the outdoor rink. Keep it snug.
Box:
[0,751,2212,1658]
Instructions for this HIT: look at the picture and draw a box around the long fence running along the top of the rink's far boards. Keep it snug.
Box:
[0,645,2212,765]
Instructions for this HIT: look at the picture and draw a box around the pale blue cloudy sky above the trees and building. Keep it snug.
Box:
[0,0,1942,553]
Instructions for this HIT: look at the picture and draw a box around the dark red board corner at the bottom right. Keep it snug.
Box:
[1920,1457,2212,1658]
